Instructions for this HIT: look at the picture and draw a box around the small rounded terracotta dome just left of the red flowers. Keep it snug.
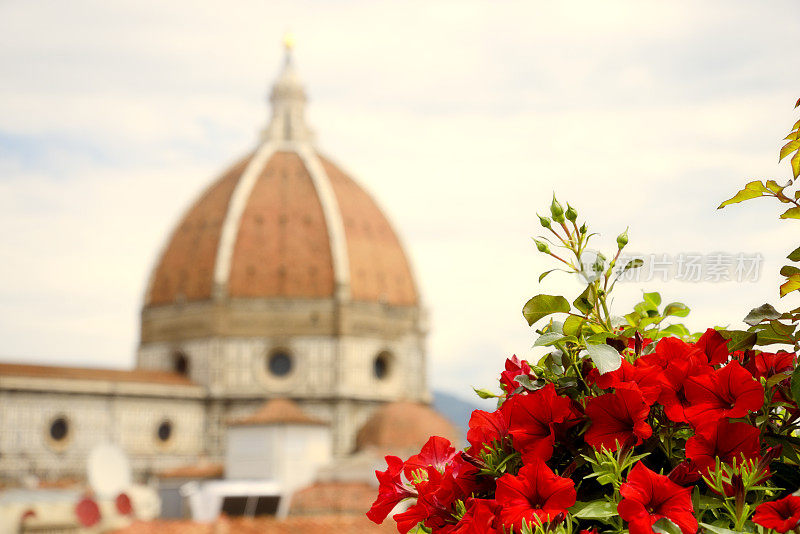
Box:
[356,401,460,451]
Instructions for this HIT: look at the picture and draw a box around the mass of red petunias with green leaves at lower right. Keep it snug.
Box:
[367,336,800,534]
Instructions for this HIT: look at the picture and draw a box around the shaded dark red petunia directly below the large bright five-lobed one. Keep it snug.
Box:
[686,419,761,473]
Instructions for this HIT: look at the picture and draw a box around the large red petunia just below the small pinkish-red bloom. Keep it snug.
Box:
[501,384,573,461]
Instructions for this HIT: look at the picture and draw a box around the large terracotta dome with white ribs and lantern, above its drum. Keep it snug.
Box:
[144,44,418,308]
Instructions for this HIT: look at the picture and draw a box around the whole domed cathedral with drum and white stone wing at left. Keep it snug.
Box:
[0,47,430,481]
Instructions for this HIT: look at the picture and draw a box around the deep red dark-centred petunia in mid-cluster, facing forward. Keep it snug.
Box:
[583,389,653,451]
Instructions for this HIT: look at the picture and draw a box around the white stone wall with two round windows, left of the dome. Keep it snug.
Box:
[0,390,205,486]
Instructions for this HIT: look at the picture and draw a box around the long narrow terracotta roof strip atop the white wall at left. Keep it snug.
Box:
[0,363,195,386]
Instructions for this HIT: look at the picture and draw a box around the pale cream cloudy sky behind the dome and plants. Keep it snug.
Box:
[0,0,800,398]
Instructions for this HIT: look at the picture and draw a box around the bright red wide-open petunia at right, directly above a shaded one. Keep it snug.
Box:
[684,361,764,426]
